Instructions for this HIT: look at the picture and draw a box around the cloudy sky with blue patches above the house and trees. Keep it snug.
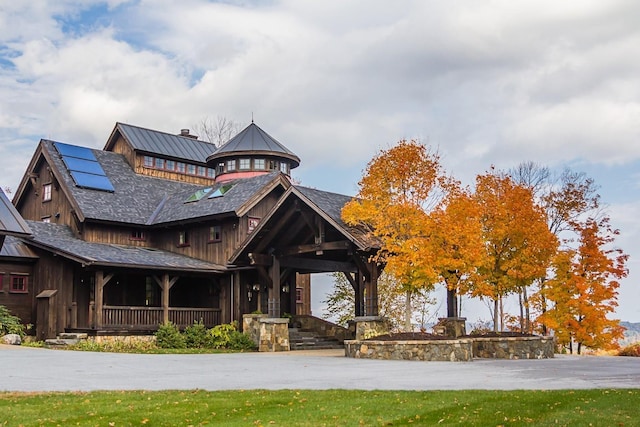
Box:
[0,0,640,322]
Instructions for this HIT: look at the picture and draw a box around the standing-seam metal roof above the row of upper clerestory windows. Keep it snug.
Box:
[116,123,216,163]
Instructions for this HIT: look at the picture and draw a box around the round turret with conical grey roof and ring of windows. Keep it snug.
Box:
[207,121,300,182]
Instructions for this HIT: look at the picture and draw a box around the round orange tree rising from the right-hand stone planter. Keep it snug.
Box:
[473,170,557,331]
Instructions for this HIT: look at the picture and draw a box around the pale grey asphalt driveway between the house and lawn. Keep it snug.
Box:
[0,345,640,391]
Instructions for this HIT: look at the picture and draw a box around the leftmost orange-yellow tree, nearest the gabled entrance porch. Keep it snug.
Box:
[342,140,453,330]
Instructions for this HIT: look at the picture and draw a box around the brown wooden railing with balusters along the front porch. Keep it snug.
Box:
[102,305,220,329]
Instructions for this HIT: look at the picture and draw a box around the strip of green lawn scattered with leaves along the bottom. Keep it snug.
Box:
[0,392,640,426]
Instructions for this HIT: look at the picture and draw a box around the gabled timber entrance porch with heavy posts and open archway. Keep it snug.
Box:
[230,186,382,318]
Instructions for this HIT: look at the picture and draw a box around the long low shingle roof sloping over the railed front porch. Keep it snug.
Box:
[27,221,225,272]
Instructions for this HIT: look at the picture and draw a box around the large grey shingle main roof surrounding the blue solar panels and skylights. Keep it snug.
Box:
[42,140,279,226]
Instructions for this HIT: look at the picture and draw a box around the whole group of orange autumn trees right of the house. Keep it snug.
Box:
[342,140,627,352]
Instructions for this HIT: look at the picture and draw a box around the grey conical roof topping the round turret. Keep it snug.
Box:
[207,122,300,168]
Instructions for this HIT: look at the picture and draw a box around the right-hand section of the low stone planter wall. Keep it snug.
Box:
[473,337,555,359]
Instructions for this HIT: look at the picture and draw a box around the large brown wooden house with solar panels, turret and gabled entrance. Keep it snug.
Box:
[0,123,378,339]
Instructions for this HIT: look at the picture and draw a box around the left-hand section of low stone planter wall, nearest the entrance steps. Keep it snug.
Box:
[344,338,473,362]
